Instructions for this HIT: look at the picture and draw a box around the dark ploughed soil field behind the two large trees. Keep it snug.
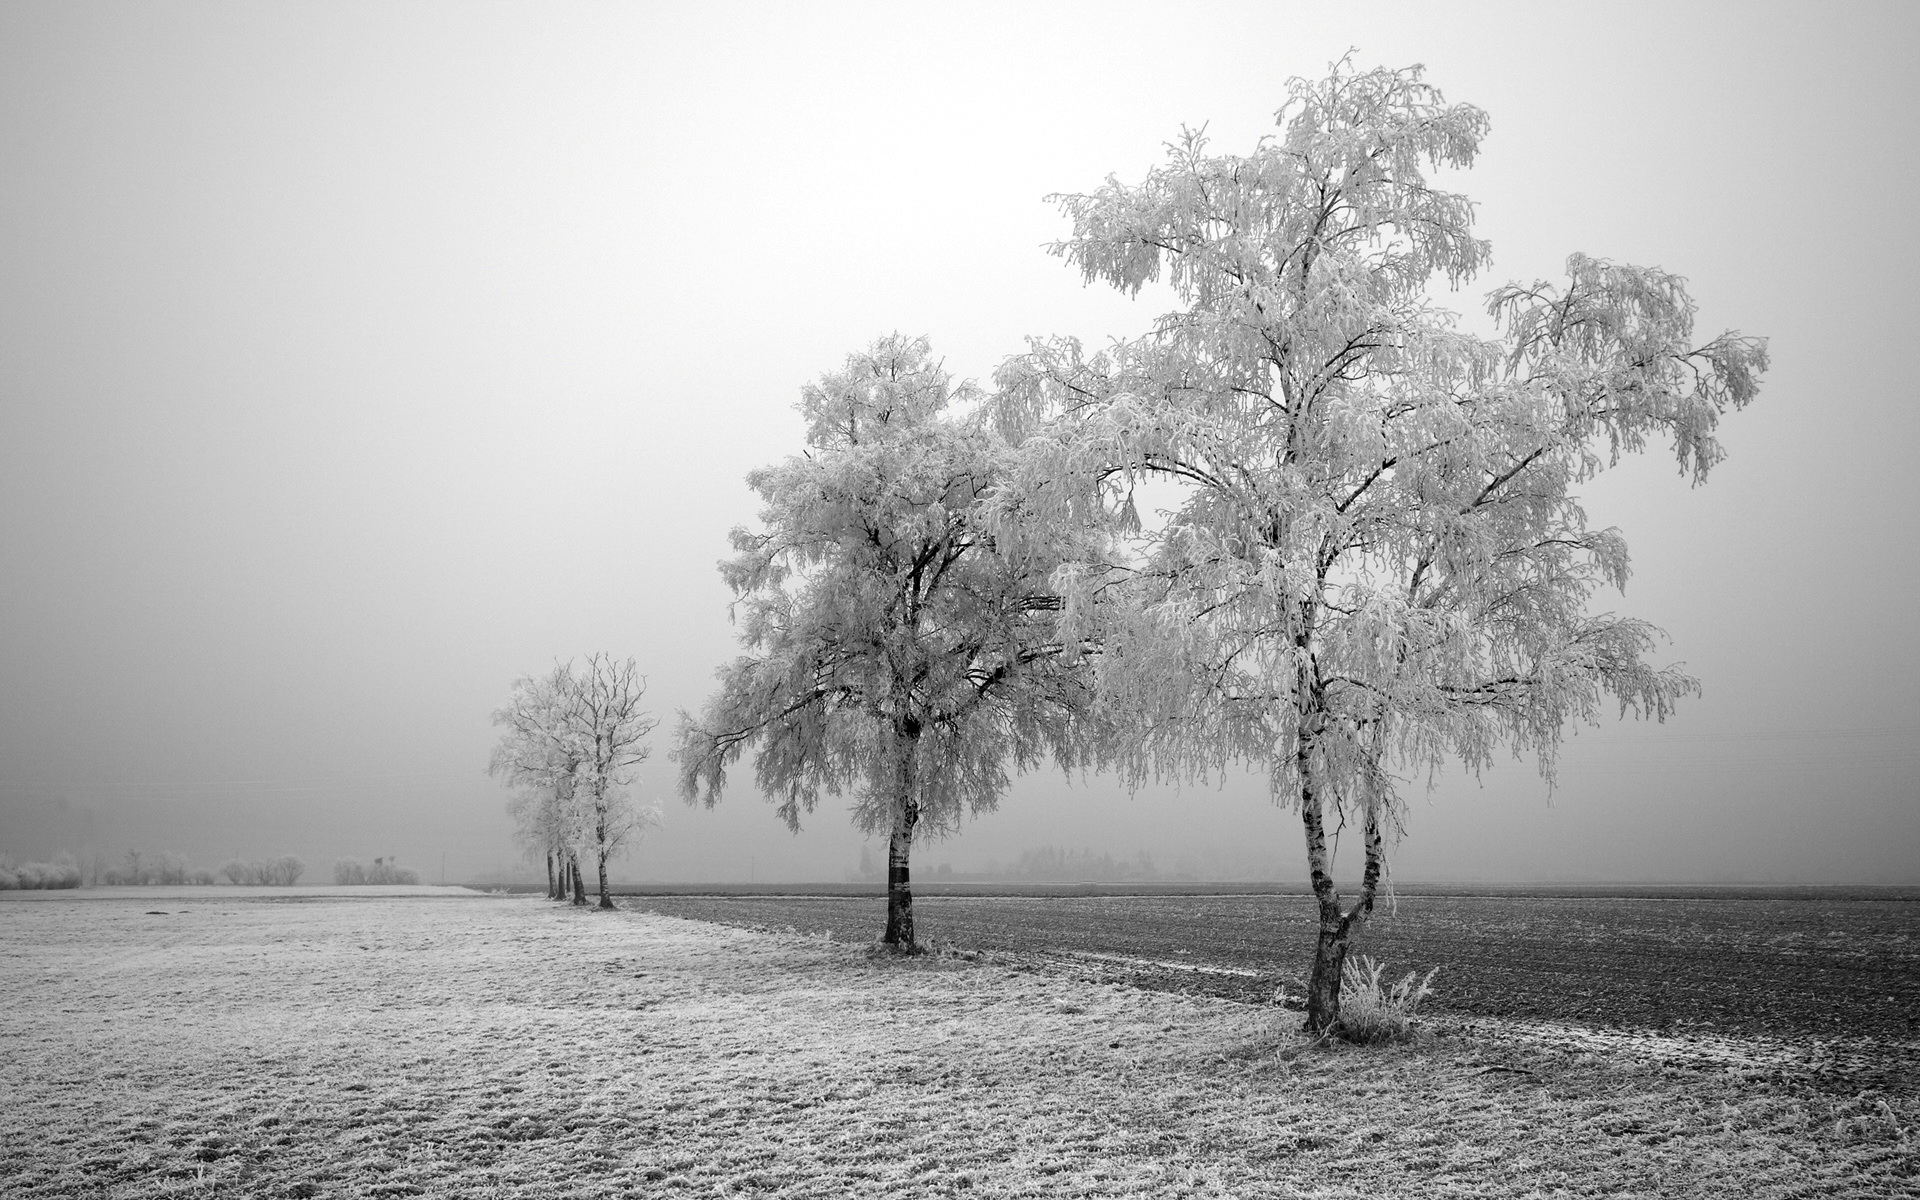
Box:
[626,889,1920,1091]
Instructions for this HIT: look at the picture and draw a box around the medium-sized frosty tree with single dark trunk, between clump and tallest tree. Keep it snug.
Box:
[676,336,1083,950]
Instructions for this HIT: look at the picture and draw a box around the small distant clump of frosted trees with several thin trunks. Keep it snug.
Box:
[488,653,659,908]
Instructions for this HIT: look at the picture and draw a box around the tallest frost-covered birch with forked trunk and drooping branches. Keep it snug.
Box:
[996,61,1766,1031]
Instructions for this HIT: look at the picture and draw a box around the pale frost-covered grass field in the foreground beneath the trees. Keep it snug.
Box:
[0,893,1920,1198]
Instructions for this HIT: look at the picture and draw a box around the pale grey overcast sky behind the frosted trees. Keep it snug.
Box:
[0,2,1920,883]
